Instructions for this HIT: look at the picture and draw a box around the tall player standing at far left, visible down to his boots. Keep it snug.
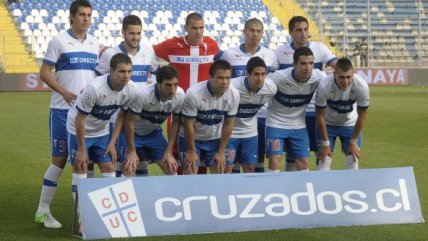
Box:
[35,0,99,228]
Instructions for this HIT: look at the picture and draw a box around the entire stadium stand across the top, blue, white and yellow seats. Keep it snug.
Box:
[0,0,428,72]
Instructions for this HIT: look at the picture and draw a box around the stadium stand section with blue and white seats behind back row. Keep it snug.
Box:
[3,0,288,70]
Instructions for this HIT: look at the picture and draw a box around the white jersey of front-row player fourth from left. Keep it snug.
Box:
[231,76,277,138]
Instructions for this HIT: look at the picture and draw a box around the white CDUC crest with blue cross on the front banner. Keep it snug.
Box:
[88,180,147,238]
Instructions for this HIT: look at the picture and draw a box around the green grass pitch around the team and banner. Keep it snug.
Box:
[0,86,428,241]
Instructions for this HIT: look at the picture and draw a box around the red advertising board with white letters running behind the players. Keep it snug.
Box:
[0,68,428,91]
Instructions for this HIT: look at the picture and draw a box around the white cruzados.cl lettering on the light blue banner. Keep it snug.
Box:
[155,179,411,222]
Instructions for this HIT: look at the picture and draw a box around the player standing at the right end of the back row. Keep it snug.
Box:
[275,16,337,171]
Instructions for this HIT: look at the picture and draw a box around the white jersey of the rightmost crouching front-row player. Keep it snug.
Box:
[315,74,370,126]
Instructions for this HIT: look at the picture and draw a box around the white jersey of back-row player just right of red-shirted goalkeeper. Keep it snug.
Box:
[220,44,279,78]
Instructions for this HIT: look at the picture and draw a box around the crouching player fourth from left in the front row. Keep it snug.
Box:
[226,56,277,172]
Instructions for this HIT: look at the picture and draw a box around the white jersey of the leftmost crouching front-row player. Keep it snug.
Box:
[67,74,137,137]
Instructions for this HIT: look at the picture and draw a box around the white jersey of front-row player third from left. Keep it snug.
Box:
[180,80,239,141]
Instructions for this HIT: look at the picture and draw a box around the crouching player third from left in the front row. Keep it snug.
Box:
[178,60,239,174]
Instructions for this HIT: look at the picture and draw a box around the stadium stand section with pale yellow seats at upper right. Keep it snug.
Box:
[297,0,428,67]
